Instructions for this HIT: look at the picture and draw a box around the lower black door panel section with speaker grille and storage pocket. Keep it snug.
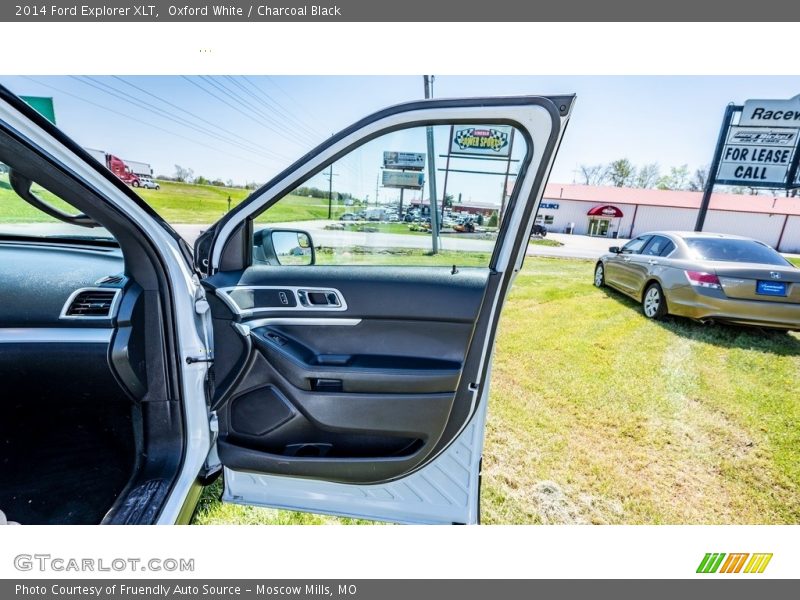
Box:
[212,351,454,483]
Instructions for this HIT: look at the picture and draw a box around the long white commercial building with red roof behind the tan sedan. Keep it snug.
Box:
[536,184,800,252]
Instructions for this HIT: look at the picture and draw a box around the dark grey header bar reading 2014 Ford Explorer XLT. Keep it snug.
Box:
[0,0,800,21]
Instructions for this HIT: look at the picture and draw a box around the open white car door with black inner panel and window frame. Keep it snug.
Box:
[196,97,573,522]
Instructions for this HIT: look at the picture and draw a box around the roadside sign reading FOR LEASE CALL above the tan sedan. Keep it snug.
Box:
[715,96,800,189]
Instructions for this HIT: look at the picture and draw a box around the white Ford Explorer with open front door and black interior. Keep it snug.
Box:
[0,89,574,524]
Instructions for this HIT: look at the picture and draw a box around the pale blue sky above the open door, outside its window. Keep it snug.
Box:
[0,75,800,188]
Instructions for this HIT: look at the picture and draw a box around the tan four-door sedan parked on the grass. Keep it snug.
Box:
[594,231,800,331]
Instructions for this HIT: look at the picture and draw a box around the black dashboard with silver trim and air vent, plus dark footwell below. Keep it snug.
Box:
[0,236,141,523]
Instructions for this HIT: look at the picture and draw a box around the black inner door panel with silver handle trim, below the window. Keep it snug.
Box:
[204,266,489,483]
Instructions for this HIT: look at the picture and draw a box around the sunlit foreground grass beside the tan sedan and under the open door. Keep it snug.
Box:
[195,257,800,524]
